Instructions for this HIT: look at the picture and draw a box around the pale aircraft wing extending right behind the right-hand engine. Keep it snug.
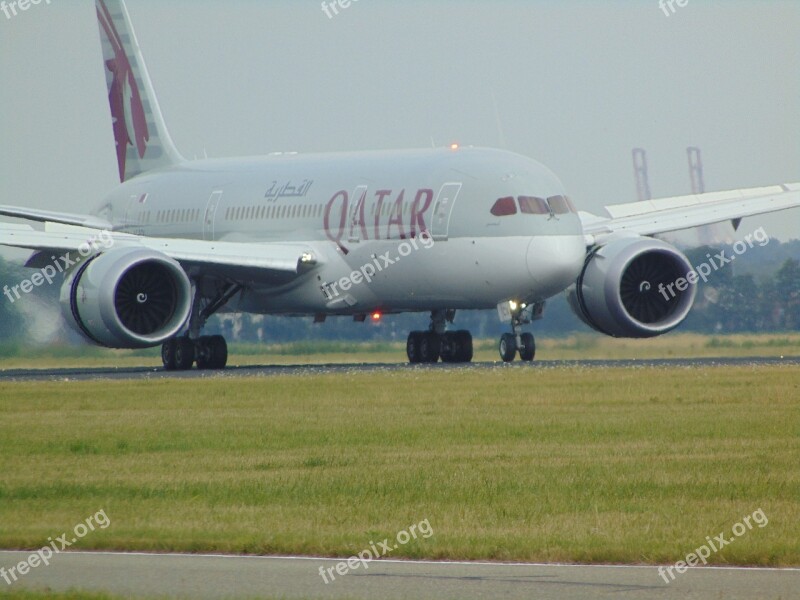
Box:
[580,183,800,246]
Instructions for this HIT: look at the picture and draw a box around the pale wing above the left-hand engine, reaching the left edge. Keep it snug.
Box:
[0,223,318,284]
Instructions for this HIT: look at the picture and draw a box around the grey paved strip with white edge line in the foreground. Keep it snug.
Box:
[0,552,800,600]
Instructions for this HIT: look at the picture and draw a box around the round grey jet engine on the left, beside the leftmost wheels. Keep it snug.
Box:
[61,248,192,349]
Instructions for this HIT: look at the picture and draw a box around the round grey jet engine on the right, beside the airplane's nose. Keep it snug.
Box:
[567,237,697,338]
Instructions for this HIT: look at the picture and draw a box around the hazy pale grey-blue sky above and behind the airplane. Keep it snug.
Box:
[0,0,800,244]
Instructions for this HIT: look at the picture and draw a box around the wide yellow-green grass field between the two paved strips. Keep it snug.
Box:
[0,366,800,566]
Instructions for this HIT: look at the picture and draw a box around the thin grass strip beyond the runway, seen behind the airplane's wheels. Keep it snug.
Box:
[0,333,800,370]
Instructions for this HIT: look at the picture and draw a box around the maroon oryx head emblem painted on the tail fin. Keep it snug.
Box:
[96,0,150,181]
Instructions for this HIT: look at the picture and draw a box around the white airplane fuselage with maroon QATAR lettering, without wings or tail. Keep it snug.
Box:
[97,148,586,314]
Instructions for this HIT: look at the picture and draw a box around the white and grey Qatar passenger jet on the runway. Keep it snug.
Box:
[0,0,800,371]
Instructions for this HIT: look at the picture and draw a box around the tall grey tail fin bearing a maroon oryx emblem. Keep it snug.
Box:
[95,0,183,182]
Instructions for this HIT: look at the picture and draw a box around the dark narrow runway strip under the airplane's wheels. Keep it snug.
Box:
[0,356,800,381]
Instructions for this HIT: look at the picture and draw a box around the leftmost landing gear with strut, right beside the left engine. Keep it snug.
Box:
[161,281,242,371]
